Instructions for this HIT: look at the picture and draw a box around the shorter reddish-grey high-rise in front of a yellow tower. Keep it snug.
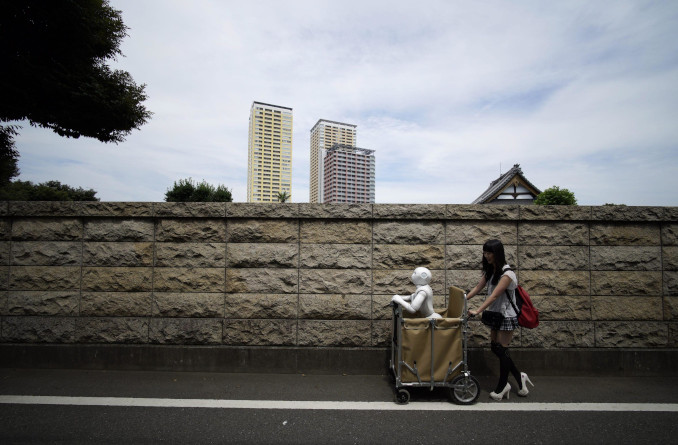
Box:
[320,144,374,203]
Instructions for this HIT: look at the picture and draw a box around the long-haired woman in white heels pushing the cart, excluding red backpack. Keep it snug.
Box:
[466,239,534,401]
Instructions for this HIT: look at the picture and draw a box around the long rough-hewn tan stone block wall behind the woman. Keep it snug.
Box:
[0,202,678,366]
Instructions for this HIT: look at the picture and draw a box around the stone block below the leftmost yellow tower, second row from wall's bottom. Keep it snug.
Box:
[225,294,299,319]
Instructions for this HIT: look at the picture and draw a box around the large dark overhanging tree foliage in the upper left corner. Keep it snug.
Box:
[0,0,152,151]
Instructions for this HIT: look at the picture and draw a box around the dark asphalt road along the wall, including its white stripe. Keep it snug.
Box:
[0,369,678,444]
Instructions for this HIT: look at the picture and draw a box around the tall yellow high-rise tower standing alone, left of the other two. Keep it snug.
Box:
[247,102,292,202]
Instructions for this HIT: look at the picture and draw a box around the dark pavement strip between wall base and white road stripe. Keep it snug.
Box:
[0,368,678,403]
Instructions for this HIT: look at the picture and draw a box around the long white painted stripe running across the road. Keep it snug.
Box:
[0,395,678,412]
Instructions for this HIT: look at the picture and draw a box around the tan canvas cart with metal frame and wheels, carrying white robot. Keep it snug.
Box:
[390,287,480,405]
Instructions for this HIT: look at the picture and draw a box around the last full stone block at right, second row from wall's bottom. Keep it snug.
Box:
[591,296,663,320]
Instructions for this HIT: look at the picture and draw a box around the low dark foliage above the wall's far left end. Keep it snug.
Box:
[0,181,99,201]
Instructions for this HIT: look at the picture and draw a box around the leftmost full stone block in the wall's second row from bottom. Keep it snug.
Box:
[6,291,80,316]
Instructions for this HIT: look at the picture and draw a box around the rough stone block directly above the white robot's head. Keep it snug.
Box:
[372,244,445,270]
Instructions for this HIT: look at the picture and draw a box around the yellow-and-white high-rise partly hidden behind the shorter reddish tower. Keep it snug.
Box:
[309,119,356,202]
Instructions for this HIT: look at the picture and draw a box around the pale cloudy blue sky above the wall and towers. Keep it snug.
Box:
[11,0,678,206]
